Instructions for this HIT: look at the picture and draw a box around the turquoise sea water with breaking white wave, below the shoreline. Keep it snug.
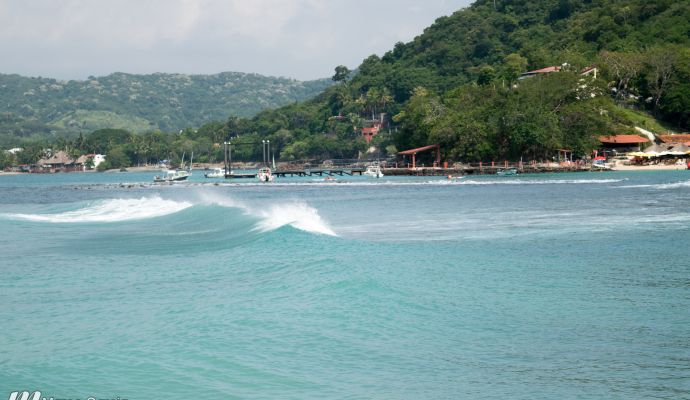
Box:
[0,171,690,399]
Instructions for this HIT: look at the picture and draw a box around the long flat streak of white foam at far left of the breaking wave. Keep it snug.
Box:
[7,196,192,223]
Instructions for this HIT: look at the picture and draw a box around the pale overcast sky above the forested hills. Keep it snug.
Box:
[0,0,471,80]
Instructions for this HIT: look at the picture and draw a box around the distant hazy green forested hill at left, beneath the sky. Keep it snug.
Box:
[0,72,331,141]
